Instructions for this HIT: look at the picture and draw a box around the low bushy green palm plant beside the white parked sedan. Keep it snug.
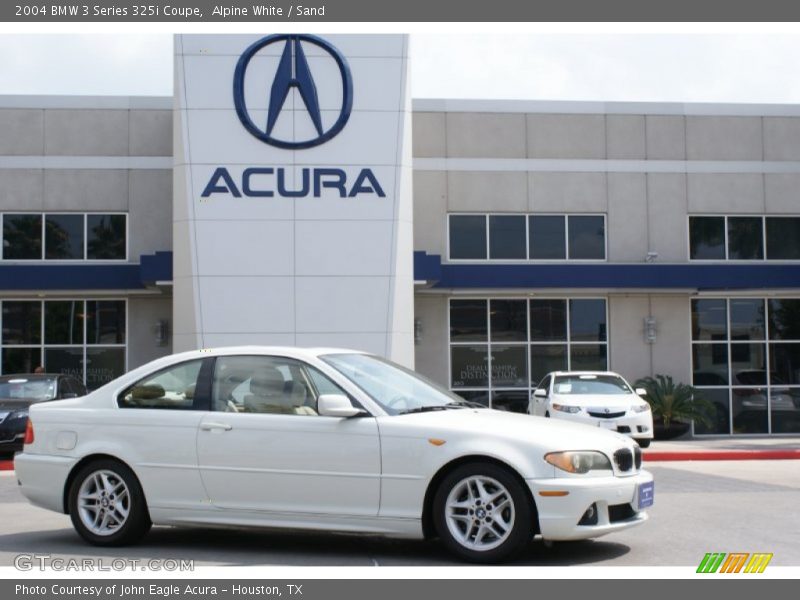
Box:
[635,375,716,429]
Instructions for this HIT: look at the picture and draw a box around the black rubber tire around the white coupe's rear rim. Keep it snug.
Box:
[67,459,152,546]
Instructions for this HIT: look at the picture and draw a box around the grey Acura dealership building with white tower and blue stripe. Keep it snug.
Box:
[0,35,800,435]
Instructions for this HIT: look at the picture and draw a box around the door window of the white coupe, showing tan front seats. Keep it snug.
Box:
[216,356,322,416]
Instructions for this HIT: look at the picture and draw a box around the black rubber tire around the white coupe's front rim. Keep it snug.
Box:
[433,462,536,563]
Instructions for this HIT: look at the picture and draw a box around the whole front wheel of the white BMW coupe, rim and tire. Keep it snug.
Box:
[433,462,535,563]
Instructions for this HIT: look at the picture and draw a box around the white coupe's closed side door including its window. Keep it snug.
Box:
[197,356,380,515]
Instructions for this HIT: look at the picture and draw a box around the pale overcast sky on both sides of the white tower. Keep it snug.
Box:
[0,34,800,103]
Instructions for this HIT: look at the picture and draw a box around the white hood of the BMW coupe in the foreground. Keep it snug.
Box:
[381,408,633,454]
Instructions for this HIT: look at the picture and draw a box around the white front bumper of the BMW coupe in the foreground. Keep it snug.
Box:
[527,471,653,540]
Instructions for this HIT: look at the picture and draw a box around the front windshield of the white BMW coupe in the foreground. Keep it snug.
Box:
[320,354,470,415]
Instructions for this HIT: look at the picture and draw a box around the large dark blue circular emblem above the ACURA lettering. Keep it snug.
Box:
[233,34,353,150]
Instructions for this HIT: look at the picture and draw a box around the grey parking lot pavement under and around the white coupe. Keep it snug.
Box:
[0,460,800,567]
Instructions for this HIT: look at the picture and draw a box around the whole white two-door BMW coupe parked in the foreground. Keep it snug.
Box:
[16,347,653,562]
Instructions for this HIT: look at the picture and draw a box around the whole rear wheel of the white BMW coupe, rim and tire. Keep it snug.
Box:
[68,460,151,546]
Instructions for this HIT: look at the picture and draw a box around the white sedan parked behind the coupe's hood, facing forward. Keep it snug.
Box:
[528,371,653,448]
